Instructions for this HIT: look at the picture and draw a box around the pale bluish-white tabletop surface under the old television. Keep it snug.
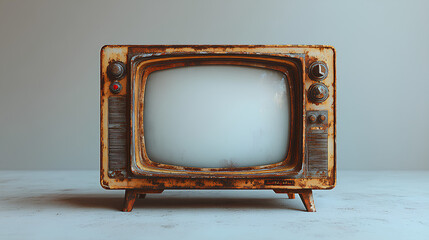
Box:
[0,171,429,240]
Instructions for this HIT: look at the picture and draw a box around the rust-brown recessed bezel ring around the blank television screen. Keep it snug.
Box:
[130,53,304,177]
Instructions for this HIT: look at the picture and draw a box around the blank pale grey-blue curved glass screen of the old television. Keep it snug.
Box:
[143,65,290,168]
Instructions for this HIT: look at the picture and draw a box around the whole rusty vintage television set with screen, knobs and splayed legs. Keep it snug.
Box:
[100,45,336,212]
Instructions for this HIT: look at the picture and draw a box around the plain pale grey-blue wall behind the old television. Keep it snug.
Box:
[0,0,429,170]
